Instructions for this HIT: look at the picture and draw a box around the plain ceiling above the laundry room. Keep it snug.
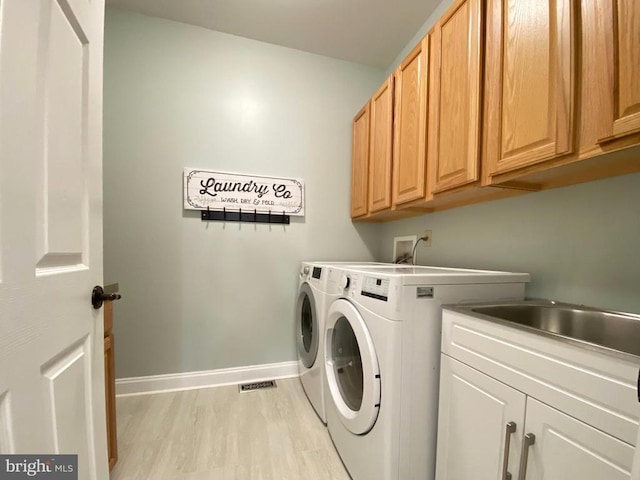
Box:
[106,0,440,68]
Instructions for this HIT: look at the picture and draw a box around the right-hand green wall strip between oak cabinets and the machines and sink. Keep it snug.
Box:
[381,174,640,313]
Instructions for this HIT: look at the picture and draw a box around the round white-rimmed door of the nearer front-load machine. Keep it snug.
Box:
[324,299,380,434]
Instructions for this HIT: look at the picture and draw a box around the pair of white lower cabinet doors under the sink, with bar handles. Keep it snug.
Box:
[436,355,635,480]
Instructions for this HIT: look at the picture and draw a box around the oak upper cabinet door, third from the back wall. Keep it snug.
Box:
[393,35,429,205]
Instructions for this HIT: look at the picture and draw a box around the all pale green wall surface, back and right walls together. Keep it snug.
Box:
[104,0,640,378]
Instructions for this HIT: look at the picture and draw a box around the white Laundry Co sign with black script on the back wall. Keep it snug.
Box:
[184,168,304,216]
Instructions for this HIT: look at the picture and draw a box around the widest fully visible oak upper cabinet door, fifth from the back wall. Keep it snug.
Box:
[485,0,576,175]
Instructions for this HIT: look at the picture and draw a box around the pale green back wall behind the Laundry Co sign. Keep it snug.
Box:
[104,10,384,377]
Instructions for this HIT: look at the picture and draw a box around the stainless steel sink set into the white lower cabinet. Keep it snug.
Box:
[454,301,640,357]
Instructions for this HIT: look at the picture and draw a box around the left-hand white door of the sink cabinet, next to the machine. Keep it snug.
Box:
[436,355,526,480]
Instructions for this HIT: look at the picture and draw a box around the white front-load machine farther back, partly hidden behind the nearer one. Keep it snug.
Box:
[296,262,393,423]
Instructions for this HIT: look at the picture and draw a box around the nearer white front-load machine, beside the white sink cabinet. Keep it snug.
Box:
[324,266,529,480]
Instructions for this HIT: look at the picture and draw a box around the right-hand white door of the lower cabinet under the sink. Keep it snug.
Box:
[519,398,633,480]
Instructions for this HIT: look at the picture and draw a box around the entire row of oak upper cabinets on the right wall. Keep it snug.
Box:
[351,0,640,221]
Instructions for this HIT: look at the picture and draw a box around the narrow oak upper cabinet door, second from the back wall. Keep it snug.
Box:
[369,76,393,213]
